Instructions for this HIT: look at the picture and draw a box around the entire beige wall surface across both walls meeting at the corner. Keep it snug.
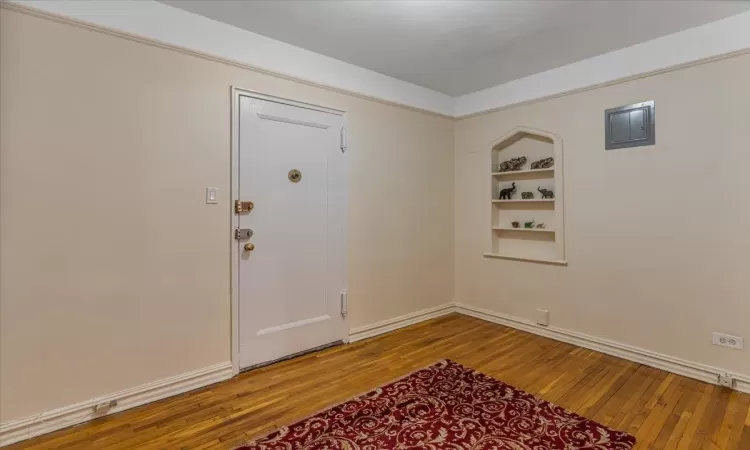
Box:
[0,0,750,428]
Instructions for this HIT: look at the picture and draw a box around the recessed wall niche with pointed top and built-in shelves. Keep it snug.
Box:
[484,127,567,265]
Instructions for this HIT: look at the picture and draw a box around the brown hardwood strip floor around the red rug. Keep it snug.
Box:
[8,314,750,450]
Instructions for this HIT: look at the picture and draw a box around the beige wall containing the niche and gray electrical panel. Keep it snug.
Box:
[455,51,750,374]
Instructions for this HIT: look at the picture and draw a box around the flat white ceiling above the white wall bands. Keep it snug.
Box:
[163,0,750,96]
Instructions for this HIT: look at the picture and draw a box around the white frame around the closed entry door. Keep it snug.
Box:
[229,86,351,375]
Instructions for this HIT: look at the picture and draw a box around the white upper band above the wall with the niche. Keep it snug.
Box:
[453,12,750,117]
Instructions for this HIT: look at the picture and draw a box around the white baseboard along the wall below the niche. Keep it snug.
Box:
[455,303,750,393]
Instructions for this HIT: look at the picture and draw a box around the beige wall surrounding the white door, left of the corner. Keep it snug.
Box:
[0,9,453,422]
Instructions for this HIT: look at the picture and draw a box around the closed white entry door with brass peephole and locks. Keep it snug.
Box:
[237,95,347,368]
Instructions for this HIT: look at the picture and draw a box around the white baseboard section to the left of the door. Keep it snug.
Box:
[0,361,232,447]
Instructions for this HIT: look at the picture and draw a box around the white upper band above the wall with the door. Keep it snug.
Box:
[9,0,454,116]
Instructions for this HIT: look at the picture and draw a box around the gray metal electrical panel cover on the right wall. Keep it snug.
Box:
[604,100,656,150]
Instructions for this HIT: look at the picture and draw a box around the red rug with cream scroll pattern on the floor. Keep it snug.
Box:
[240,360,635,450]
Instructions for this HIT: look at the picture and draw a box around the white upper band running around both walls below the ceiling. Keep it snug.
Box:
[0,0,750,118]
